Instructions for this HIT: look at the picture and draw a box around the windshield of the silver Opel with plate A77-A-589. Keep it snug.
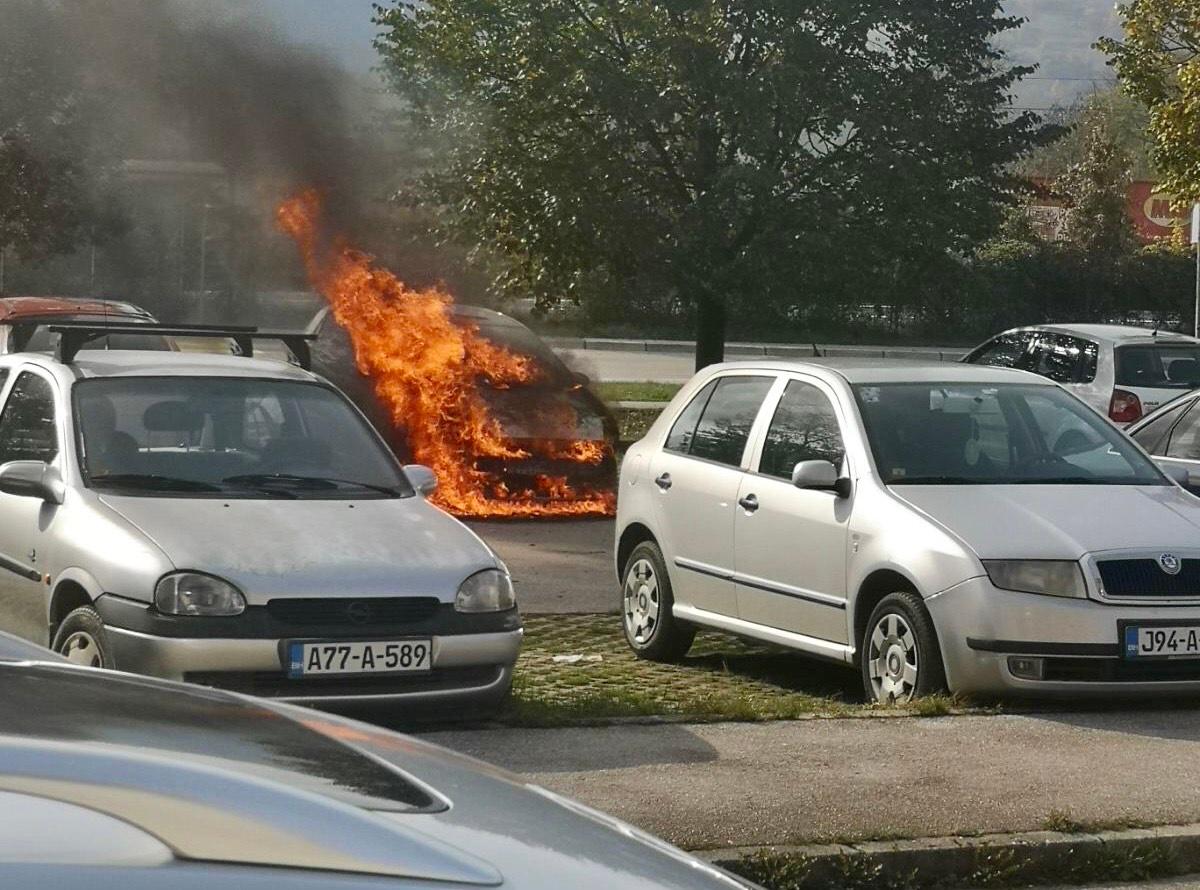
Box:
[74,377,413,499]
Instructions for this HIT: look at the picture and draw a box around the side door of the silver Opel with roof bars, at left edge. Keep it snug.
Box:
[0,368,61,645]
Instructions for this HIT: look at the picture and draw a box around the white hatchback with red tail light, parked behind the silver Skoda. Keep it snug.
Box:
[962,324,1200,426]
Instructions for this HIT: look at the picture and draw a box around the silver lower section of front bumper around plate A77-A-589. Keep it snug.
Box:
[106,627,523,704]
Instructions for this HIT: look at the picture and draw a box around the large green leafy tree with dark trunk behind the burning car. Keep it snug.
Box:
[378,0,1040,366]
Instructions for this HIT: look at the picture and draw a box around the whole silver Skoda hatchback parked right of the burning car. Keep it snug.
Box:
[616,361,1200,702]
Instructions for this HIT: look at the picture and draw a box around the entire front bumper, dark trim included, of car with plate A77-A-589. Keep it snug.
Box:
[96,596,523,704]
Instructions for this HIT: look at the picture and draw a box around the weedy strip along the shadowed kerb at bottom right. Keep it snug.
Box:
[727,841,1181,890]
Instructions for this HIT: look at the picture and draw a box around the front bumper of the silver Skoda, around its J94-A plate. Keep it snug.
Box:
[925,578,1200,697]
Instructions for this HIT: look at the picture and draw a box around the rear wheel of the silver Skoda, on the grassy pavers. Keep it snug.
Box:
[620,541,696,661]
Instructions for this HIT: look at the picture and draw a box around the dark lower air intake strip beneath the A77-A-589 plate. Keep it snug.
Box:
[184,665,503,698]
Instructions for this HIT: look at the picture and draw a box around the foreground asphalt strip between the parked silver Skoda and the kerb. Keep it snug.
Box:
[430,710,1200,849]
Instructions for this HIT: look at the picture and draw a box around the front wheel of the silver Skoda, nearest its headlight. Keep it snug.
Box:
[860,590,946,704]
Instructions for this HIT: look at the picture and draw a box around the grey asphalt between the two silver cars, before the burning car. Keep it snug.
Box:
[468,519,617,614]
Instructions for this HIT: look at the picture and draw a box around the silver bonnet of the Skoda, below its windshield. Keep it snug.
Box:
[890,485,1200,559]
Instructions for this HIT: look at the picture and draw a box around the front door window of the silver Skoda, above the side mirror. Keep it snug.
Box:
[758,380,846,480]
